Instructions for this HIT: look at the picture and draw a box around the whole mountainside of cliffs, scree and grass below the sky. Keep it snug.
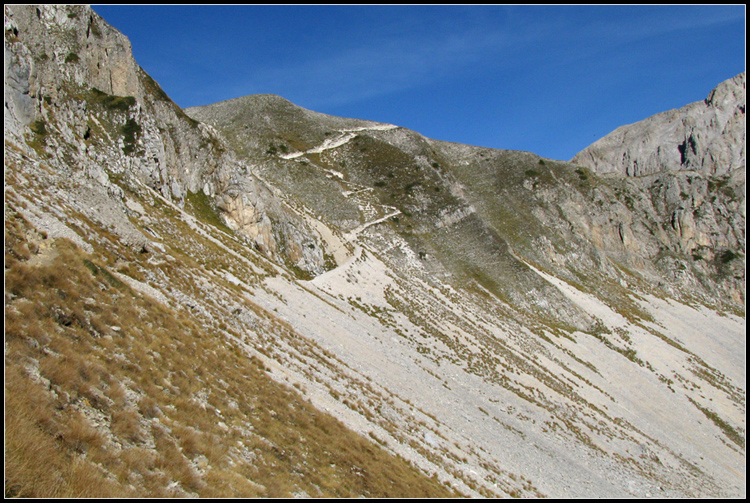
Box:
[4,6,745,497]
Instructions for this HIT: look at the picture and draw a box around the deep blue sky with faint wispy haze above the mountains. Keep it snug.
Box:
[92,5,745,160]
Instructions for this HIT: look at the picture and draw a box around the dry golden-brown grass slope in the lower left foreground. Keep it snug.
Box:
[5,209,456,497]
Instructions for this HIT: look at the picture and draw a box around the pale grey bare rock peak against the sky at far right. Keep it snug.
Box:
[571,72,745,176]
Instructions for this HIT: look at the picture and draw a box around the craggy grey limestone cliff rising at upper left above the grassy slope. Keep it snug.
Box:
[4,5,323,274]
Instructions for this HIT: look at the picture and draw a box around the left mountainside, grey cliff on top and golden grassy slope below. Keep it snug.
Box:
[4,5,455,497]
